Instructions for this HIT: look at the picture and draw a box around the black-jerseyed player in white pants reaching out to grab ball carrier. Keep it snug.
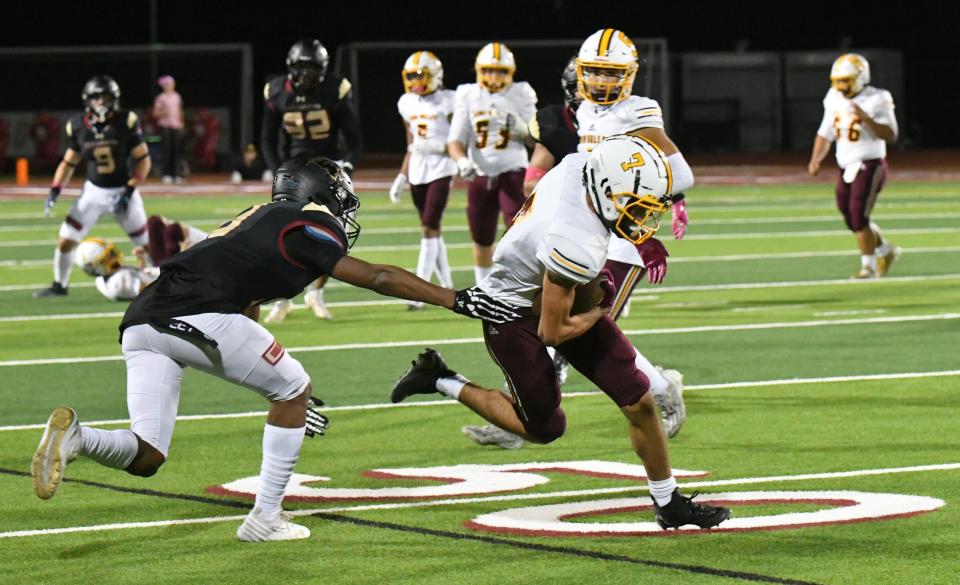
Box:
[31,157,519,541]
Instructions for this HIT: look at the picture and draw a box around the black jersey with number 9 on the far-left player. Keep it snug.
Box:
[67,110,143,188]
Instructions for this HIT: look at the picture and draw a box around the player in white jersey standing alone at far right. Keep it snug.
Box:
[807,53,900,278]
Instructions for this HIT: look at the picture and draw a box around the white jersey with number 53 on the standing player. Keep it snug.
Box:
[448,81,537,177]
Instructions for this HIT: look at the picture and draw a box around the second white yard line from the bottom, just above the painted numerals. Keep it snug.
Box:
[0,370,960,432]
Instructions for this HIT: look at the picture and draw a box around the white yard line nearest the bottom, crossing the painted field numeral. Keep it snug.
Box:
[0,463,960,538]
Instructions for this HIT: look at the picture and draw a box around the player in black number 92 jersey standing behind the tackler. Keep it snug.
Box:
[260,39,363,322]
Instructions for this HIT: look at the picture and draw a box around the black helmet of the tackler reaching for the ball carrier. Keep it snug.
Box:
[271,155,360,249]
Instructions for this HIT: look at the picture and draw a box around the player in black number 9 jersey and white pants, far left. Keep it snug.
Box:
[33,75,150,297]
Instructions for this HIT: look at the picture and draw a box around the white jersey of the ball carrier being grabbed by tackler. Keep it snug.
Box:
[480,153,610,307]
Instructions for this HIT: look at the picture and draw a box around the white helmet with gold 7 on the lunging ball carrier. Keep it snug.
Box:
[583,134,673,244]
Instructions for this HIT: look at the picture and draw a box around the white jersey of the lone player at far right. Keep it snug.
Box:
[817,85,898,169]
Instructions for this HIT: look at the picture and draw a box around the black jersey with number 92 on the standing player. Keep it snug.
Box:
[260,75,363,171]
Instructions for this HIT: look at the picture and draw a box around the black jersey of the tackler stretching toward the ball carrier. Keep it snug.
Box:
[120,202,347,332]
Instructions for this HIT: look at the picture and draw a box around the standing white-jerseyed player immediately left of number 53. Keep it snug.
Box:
[390,51,457,310]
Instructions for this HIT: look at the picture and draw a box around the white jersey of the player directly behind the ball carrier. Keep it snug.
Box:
[577,95,663,266]
